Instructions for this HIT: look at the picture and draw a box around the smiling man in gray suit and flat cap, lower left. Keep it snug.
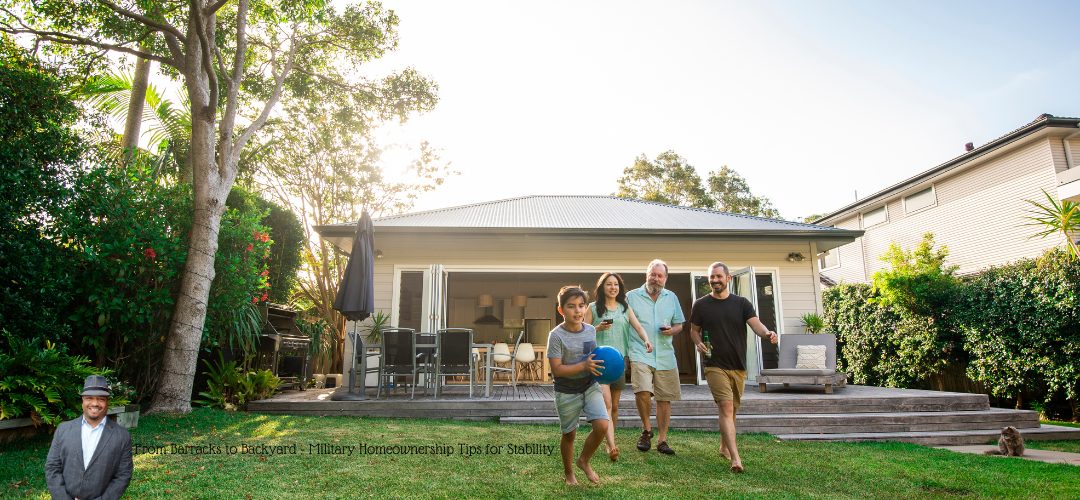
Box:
[45,375,132,499]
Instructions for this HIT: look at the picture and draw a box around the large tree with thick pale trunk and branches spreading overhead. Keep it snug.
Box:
[0,0,435,413]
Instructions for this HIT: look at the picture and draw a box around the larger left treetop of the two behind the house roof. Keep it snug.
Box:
[615,150,713,208]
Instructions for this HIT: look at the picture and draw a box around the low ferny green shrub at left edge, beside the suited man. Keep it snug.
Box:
[0,330,108,425]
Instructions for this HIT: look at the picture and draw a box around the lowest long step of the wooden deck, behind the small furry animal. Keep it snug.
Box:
[777,424,1080,445]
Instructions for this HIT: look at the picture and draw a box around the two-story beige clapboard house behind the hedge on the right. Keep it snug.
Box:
[814,114,1080,283]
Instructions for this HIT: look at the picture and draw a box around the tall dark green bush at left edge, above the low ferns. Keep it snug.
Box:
[0,37,84,339]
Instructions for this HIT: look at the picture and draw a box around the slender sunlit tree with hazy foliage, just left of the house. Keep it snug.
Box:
[253,103,454,371]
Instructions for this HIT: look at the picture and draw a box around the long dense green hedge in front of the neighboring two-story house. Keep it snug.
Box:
[823,249,1080,419]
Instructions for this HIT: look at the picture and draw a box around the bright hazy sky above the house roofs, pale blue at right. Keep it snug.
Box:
[361,0,1080,219]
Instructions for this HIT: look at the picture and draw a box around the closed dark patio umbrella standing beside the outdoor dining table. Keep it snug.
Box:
[332,211,375,400]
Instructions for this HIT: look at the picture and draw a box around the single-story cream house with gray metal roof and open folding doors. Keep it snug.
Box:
[315,195,862,383]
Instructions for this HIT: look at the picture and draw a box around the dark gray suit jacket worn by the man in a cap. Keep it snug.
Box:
[45,417,133,499]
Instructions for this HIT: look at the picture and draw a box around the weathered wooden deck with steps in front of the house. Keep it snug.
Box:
[248,384,1080,445]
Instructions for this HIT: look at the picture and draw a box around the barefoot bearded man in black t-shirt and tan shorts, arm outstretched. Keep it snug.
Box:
[690,262,777,472]
